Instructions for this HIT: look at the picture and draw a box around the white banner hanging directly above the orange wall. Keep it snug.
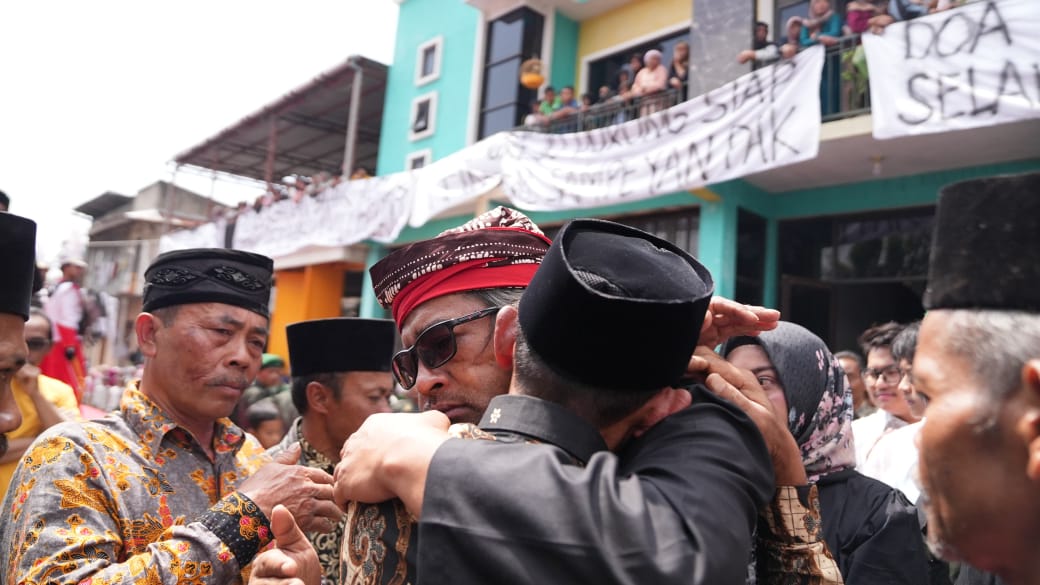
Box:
[233,173,415,257]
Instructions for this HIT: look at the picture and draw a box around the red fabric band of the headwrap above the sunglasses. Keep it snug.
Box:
[391,258,539,329]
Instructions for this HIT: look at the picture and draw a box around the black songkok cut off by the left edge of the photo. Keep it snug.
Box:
[0,212,36,319]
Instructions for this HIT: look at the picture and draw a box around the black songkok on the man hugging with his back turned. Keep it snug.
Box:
[519,220,713,390]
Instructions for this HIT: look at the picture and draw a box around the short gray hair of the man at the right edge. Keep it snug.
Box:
[943,309,1040,401]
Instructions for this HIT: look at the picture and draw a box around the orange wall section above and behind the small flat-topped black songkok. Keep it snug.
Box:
[267,262,346,360]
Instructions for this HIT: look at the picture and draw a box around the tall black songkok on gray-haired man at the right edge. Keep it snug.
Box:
[925,173,1040,312]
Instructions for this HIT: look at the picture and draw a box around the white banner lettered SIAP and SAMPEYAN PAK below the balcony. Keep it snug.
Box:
[501,46,824,210]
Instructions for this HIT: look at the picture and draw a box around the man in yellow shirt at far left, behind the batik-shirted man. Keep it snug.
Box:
[0,309,79,500]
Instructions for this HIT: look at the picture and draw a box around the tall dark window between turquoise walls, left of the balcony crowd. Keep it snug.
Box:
[479,7,545,138]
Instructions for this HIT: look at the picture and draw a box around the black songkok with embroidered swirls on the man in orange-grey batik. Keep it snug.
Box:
[142,248,274,316]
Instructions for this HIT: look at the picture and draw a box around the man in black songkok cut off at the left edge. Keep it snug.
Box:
[0,208,36,458]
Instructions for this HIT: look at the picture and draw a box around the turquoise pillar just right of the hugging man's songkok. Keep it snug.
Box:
[697,196,737,299]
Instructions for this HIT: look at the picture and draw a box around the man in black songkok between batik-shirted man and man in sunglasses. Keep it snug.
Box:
[267,319,395,583]
